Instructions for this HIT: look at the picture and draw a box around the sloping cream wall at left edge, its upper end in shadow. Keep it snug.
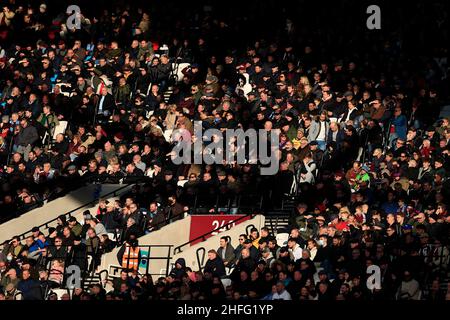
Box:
[0,184,131,243]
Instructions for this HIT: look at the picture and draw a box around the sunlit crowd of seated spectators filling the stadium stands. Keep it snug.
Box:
[0,1,450,300]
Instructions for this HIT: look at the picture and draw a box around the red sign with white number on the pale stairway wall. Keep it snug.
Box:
[189,214,250,246]
